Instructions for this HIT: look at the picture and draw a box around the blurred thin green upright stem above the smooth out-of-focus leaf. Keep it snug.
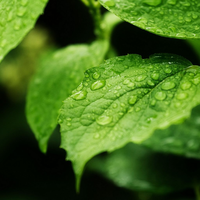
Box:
[81,0,105,39]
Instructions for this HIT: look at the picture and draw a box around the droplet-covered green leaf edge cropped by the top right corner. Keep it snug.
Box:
[99,0,200,38]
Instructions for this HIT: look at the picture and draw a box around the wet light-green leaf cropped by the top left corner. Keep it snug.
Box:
[0,0,48,61]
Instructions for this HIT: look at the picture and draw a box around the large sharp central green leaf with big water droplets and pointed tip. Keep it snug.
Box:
[59,54,200,188]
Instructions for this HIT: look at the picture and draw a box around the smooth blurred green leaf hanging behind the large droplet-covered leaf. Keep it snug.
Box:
[26,41,108,152]
